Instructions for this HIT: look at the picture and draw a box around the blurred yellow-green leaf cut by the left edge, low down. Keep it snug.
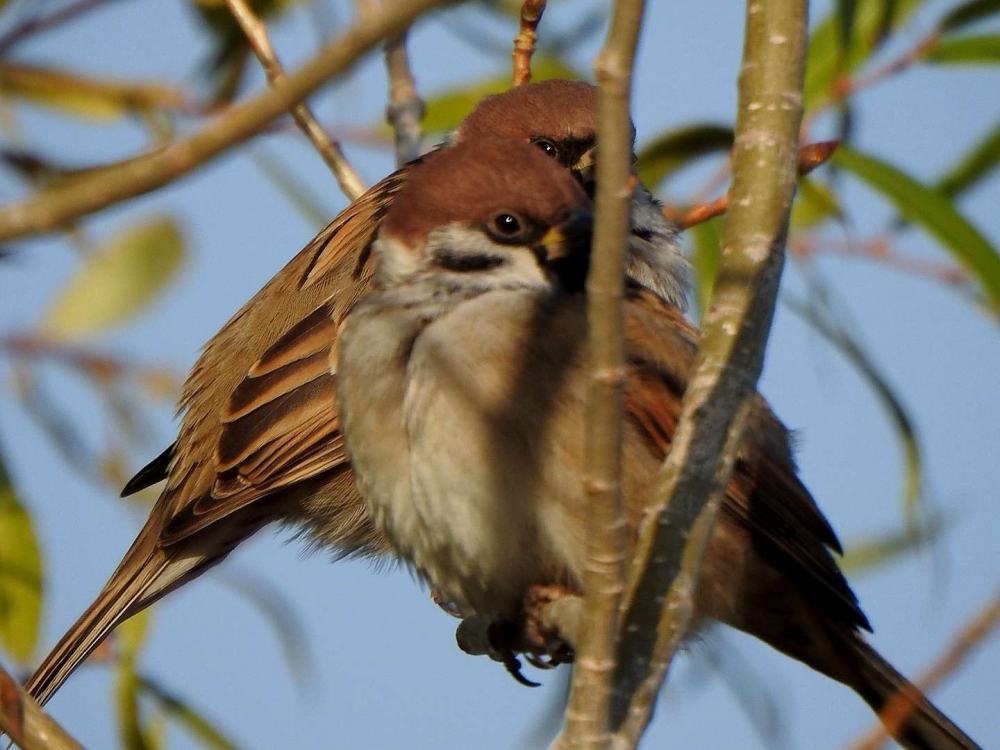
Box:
[0,456,42,662]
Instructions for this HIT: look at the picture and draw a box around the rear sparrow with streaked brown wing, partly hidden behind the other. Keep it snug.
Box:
[25,80,688,704]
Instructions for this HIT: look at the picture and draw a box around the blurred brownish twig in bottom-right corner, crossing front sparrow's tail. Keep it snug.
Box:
[851,592,1000,750]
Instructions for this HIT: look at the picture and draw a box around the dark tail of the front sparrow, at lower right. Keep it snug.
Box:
[851,637,979,750]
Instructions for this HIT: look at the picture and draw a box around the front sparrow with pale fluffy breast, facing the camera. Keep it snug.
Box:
[340,140,976,750]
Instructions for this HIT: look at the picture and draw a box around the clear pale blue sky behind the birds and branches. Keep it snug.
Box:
[0,0,1000,749]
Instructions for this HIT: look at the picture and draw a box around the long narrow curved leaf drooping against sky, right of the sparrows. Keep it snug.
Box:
[784,293,923,531]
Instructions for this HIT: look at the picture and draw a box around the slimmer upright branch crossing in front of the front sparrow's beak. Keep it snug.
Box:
[561,0,645,748]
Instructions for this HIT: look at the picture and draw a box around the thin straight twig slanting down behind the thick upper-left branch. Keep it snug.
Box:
[226,0,365,201]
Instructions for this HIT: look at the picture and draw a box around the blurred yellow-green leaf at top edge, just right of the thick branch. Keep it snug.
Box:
[804,0,924,112]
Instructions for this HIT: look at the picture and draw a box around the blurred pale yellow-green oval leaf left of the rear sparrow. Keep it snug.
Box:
[42,217,184,338]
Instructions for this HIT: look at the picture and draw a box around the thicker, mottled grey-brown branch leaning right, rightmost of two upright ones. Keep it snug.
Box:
[611,0,807,746]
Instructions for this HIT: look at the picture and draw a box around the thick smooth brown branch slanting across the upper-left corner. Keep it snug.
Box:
[0,0,448,242]
